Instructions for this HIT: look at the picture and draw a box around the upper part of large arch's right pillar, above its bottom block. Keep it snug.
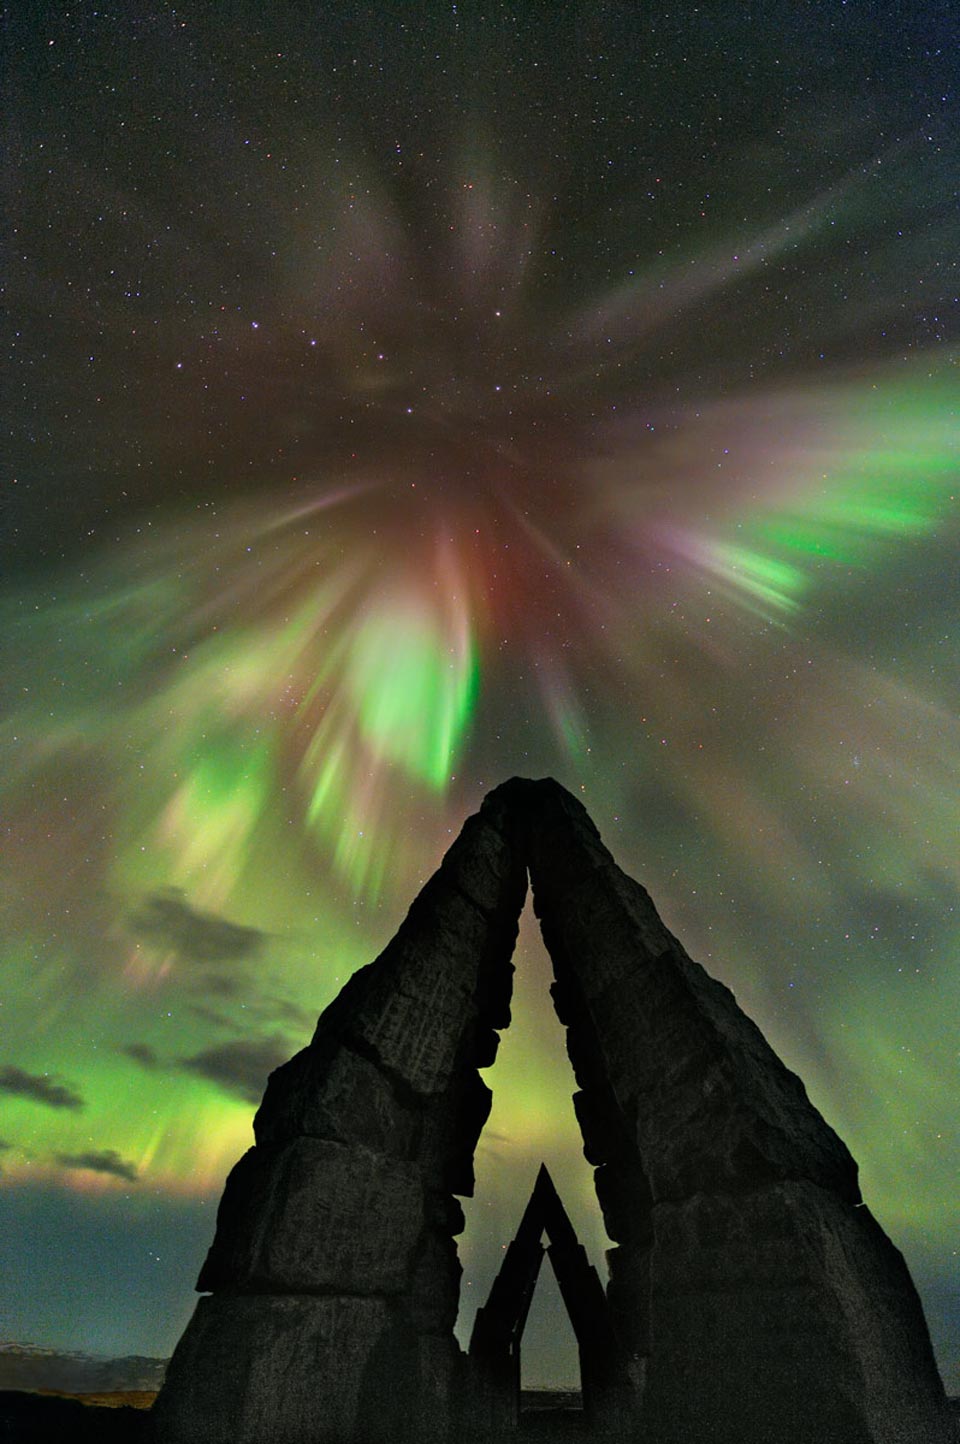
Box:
[516,784,860,1203]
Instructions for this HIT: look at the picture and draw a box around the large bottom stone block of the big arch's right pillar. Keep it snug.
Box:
[642,1183,953,1444]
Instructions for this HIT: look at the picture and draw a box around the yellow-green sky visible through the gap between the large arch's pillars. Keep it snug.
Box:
[456,898,614,1388]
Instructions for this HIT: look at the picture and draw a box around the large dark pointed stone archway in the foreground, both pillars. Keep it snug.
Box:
[153,778,951,1444]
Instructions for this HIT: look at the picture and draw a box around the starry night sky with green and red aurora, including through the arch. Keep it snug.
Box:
[0,0,960,1393]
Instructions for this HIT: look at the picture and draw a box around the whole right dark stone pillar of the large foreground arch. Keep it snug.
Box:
[508,781,951,1444]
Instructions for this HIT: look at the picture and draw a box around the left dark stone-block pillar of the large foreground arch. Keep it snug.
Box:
[153,800,527,1444]
